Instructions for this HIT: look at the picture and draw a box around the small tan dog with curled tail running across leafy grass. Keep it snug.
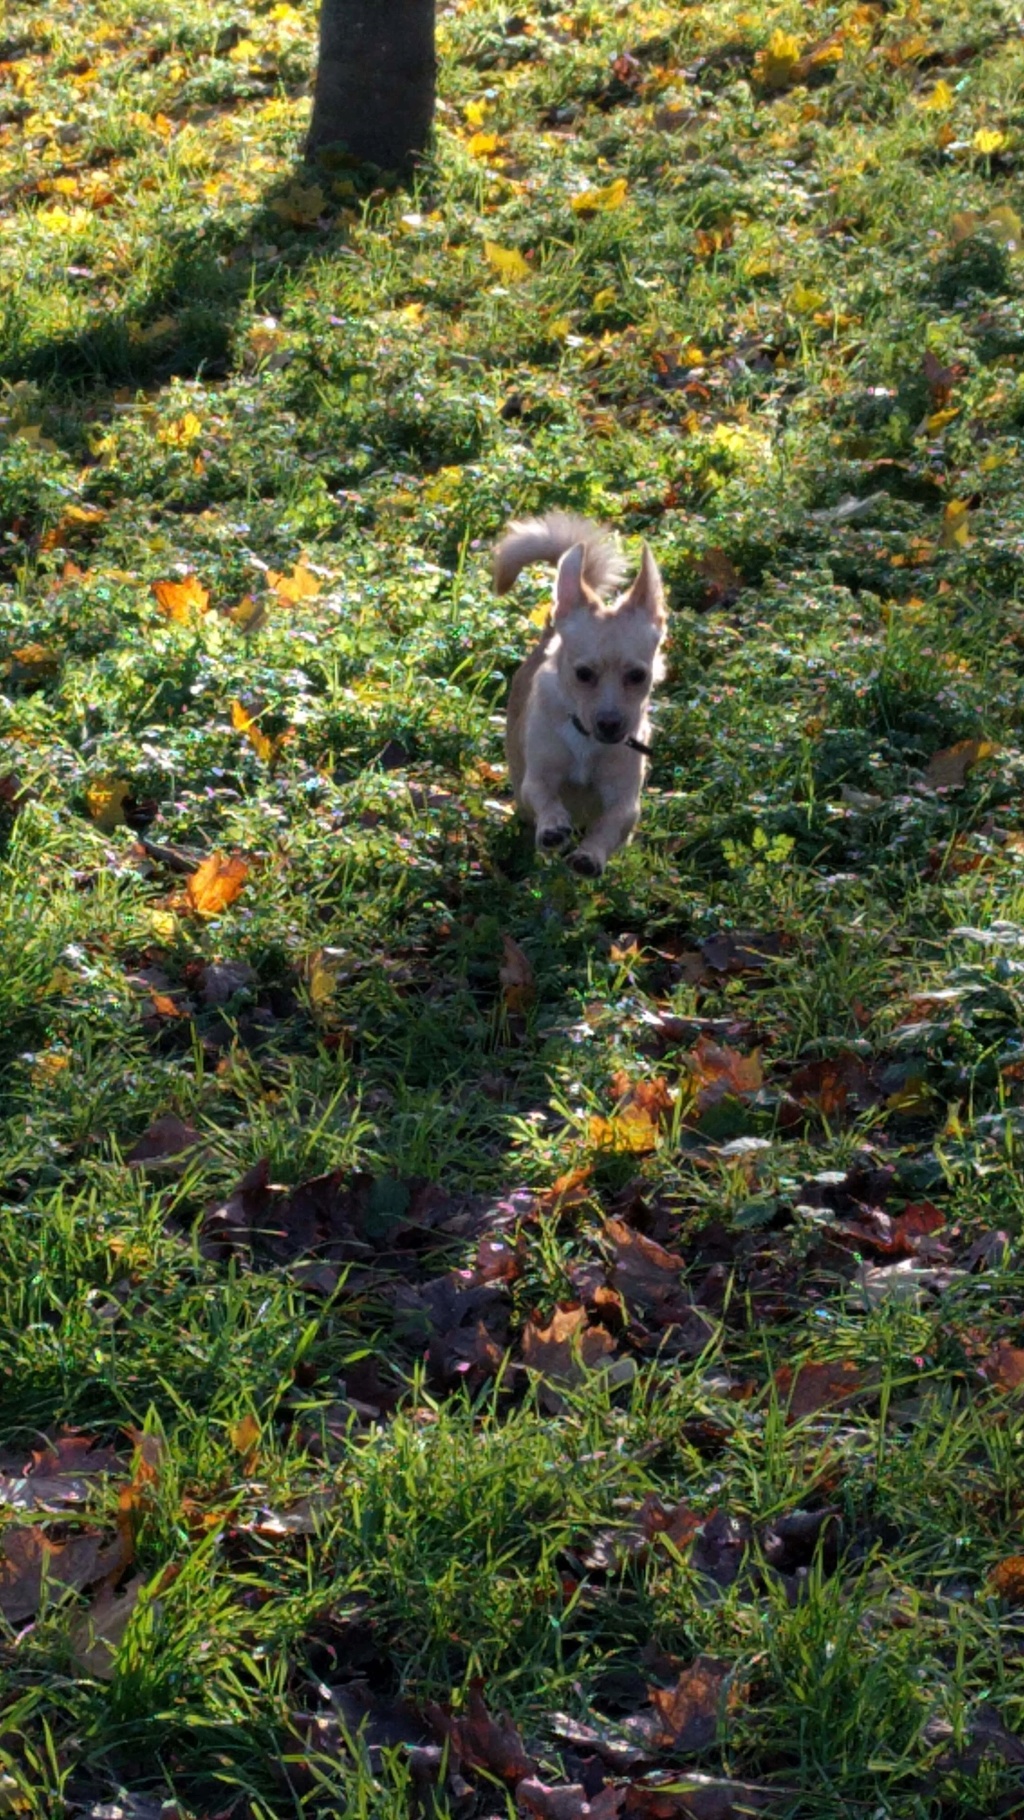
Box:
[495,511,666,879]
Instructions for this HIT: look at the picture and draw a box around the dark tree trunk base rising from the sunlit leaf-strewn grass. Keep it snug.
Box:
[306,0,437,177]
